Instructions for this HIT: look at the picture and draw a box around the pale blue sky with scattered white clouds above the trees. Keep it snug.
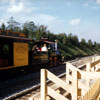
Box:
[0,0,100,43]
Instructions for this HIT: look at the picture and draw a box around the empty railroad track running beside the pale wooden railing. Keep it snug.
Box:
[4,56,98,100]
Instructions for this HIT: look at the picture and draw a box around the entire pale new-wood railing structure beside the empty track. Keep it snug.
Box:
[39,56,100,100]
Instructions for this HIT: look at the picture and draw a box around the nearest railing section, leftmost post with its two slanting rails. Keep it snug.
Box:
[41,69,70,100]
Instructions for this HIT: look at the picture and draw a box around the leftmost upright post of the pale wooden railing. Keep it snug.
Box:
[41,69,47,100]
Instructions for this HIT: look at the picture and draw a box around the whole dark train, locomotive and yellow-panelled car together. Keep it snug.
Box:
[0,29,62,72]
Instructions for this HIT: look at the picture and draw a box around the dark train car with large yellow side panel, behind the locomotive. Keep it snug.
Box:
[0,30,31,71]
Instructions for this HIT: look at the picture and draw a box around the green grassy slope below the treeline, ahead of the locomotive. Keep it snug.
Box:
[58,40,100,59]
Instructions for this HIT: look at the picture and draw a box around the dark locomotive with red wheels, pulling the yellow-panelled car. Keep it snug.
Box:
[31,40,62,68]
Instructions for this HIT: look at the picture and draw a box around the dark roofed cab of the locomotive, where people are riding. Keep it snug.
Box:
[31,41,50,66]
